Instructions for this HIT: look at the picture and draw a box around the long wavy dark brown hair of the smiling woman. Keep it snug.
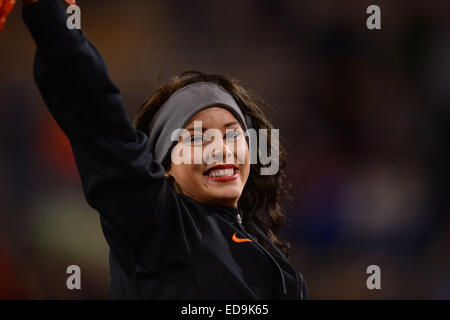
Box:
[133,71,291,257]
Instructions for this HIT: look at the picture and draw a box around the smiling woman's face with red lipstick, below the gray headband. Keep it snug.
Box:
[167,107,250,207]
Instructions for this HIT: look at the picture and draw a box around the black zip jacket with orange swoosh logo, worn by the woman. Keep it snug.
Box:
[23,0,306,299]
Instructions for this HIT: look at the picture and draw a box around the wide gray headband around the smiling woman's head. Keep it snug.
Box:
[149,82,251,163]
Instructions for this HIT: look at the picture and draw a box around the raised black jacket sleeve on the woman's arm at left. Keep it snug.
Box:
[23,0,192,273]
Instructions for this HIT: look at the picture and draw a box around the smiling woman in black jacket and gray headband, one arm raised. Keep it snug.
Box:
[17,0,306,299]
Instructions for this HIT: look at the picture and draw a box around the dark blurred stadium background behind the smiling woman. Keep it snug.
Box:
[0,0,450,299]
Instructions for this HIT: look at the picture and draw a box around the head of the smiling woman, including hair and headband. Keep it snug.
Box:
[134,71,289,256]
